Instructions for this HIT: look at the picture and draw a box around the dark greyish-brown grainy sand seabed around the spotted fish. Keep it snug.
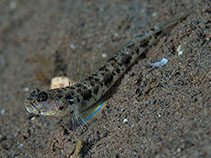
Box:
[0,0,211,158]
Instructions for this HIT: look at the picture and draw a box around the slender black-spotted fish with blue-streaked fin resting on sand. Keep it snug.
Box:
[25,11,191,128]
